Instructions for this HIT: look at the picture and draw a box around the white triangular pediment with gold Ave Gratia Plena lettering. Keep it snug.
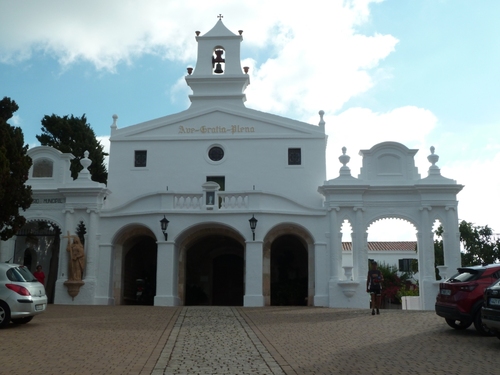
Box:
[110,106,326,141]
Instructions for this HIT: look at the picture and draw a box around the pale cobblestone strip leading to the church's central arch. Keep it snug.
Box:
[153,307,284,375]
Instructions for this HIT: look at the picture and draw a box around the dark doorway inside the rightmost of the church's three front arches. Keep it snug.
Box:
[271,235,308,306]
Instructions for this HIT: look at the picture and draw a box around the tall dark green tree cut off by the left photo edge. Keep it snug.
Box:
[0,97,33,241]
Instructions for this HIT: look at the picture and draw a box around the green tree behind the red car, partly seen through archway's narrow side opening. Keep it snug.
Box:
[434,220,500,266]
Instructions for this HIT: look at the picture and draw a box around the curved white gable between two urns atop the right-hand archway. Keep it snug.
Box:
[358,142,420,182]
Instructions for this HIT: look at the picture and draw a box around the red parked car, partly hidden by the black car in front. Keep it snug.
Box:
[435,264,500,335]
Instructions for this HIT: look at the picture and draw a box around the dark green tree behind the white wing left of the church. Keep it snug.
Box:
[36,114,108,183]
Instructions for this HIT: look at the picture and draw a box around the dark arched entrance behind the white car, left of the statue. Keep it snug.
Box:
[11,220,61,303]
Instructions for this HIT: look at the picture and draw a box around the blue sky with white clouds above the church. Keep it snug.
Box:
[0,0,500,239]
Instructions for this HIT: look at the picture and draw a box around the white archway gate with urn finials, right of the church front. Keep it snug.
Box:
[318,142,463,310]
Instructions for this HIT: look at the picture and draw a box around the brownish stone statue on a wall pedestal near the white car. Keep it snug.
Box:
[64,232,85,299]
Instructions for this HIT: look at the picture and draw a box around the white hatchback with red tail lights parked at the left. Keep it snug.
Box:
[0,263,47,328]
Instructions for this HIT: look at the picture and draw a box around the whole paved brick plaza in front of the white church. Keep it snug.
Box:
[0,305,500,375]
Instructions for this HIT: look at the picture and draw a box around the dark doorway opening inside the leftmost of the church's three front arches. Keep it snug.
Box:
[123,236,157,306]
